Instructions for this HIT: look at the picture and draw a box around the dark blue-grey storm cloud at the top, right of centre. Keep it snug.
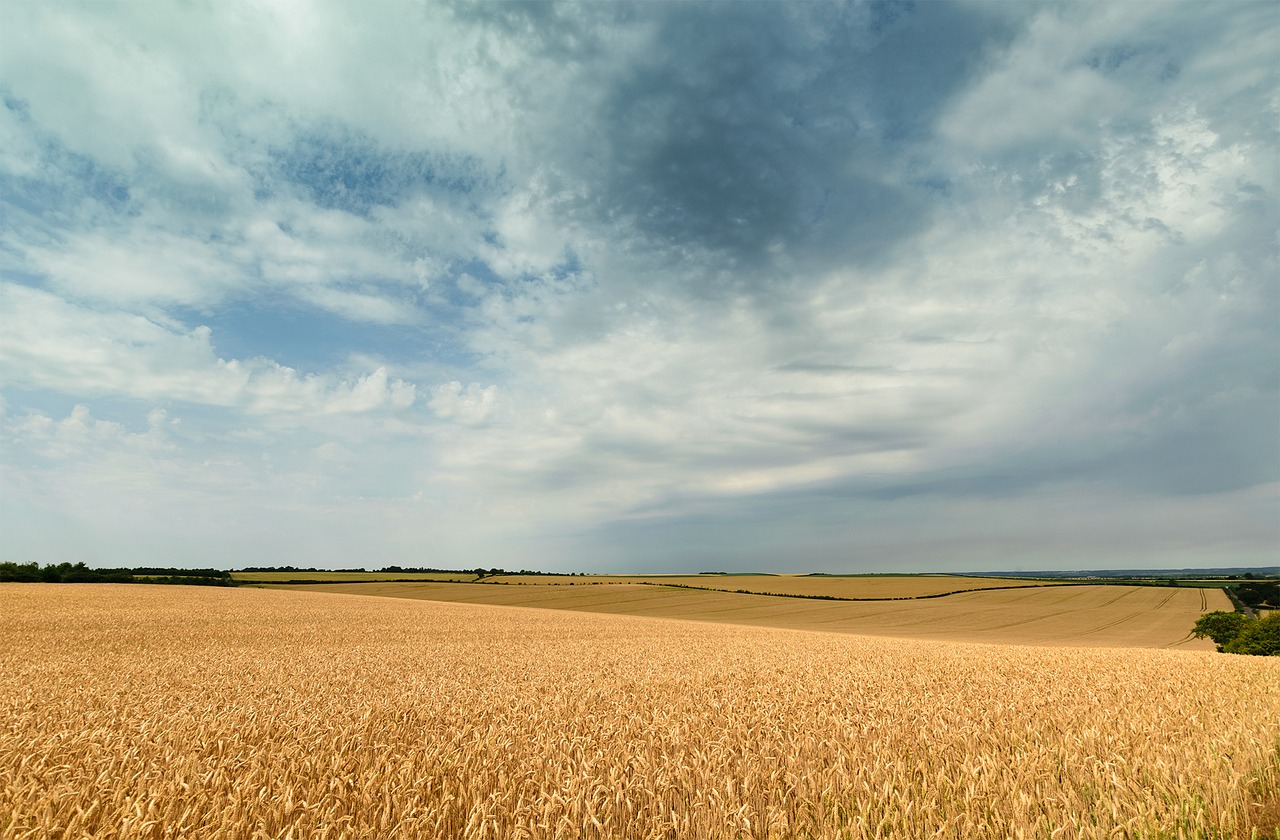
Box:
[558,3,1010,277]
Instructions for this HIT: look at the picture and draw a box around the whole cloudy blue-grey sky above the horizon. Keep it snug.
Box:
[0,0,1280,572]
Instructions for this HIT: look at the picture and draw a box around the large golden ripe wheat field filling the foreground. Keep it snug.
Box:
[0,584,1280,839]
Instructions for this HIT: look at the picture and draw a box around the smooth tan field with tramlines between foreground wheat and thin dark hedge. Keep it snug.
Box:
[280,583,1231,650]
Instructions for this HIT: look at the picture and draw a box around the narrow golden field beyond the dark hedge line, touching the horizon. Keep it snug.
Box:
[488,575,1061,598]
